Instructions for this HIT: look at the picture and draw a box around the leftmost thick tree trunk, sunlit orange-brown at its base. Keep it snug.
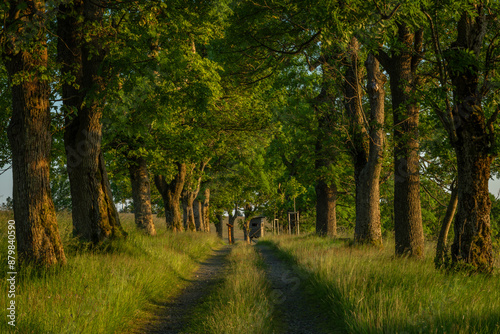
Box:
[1,1,66,271]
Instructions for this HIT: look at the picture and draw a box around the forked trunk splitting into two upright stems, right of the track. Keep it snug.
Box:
[345,48,386,246]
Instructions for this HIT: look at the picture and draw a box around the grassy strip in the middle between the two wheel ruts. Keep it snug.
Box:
[186,243,277,334]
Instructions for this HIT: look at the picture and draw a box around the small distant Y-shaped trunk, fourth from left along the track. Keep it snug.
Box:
[154,163,186,232]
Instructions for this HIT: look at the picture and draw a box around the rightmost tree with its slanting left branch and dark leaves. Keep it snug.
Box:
[425,2,500,273]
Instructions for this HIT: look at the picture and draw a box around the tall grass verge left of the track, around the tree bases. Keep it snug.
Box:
[0,214,220,334]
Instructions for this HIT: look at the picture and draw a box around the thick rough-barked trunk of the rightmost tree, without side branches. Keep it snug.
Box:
[448,9,500,273]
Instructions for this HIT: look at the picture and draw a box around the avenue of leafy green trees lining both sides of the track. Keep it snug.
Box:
[0,0,500,273]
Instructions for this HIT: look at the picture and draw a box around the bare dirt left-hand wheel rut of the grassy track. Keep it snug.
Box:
[140,246,231,334]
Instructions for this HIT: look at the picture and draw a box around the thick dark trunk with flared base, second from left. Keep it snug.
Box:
[58,0,126,243]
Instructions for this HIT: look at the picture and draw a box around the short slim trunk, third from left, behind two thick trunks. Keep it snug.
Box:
[128,157,156,236]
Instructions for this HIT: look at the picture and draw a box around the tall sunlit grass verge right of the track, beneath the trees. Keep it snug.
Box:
[268,236,500,334]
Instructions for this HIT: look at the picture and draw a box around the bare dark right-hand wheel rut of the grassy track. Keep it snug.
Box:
[255,244,325,334]
